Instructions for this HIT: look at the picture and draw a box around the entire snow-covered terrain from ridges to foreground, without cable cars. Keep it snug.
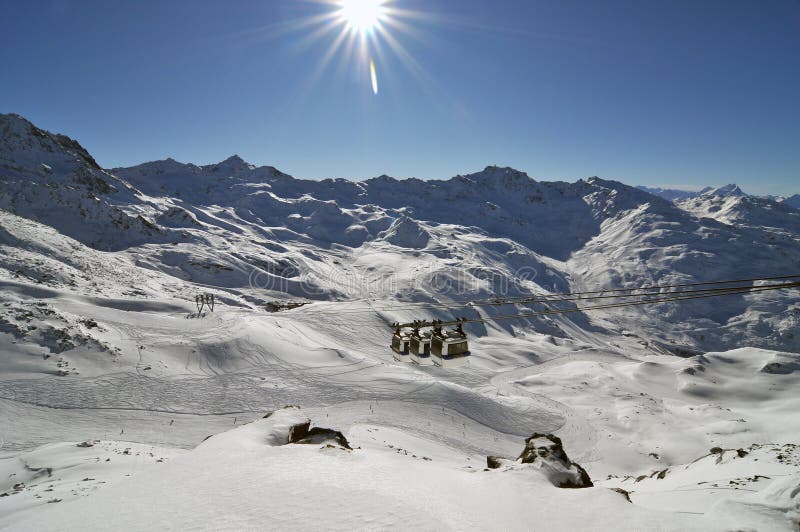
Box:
[0,115,800,530]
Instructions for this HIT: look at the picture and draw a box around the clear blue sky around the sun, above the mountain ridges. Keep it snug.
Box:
[0,0,800,193]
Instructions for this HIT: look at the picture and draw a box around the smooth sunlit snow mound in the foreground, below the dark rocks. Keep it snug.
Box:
[7,409,796,530]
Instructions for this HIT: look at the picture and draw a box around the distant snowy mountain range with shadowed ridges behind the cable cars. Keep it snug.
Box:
[0,111,800,350]
